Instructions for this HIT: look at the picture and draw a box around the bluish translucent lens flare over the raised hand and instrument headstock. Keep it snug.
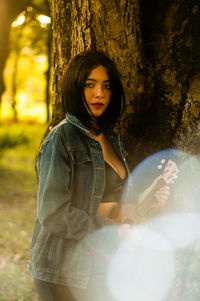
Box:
[122,149,200,218]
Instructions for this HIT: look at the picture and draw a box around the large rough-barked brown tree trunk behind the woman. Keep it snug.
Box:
[52,0,200,301]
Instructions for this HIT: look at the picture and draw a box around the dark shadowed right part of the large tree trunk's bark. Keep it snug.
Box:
[133,0,200,162]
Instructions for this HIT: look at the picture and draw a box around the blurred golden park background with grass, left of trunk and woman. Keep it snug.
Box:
[0,1,51,301]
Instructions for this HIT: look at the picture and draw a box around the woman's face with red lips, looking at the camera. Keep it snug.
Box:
[84,66,111,117]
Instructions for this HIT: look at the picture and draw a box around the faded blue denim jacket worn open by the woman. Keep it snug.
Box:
[28,114,128,288]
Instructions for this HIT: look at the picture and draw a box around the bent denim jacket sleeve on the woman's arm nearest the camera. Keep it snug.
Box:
[37,133,114,240]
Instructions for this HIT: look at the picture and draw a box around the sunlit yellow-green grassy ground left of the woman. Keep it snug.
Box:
[0,122,46,301]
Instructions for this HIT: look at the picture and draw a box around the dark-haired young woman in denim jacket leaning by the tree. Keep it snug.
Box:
[29,51,173,301]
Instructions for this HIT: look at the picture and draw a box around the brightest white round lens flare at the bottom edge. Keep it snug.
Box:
[107,226,174,301]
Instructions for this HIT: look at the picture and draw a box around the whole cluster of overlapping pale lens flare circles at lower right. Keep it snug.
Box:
[70,149,200,301]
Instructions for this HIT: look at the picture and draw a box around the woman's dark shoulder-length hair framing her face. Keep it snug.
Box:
[61,50,125,133]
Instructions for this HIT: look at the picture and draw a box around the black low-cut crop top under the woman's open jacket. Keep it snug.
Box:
[102,162,126,203]
